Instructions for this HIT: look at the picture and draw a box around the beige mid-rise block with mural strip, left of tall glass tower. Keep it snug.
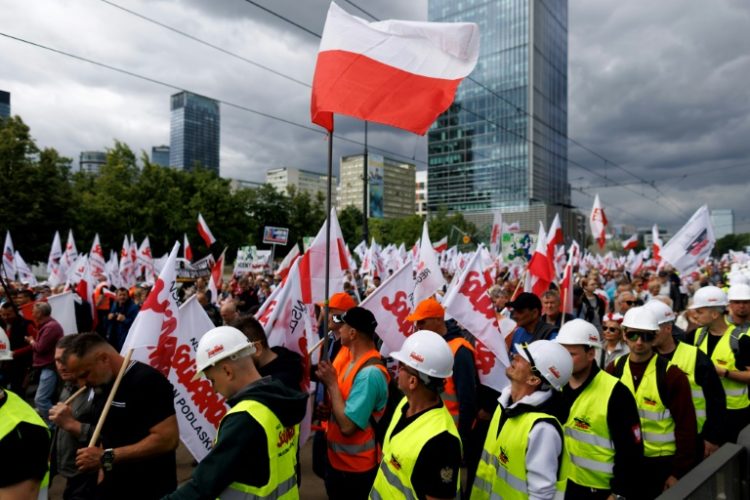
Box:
[338,154,417,219]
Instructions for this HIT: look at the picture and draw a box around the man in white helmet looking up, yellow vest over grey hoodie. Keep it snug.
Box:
[471,340,573,499]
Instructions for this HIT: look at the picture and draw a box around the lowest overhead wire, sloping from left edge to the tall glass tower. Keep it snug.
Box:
[0,32,427,168]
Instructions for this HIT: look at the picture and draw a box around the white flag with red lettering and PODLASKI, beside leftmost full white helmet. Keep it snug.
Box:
[167,295,229,462]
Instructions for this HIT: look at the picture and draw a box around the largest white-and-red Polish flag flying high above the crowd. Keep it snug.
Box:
[310,2,479,135]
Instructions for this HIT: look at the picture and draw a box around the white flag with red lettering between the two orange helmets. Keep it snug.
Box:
[360,261,414,356]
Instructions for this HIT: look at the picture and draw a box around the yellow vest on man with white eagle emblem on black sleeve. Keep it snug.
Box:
[370,398,461,500]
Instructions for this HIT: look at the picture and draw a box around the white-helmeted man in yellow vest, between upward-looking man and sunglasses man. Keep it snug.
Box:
[556,319,643,500]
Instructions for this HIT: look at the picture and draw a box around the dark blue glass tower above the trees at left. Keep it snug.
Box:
[169,92,221,174]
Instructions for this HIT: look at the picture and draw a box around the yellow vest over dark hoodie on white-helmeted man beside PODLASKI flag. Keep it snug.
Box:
[216,399,299,500]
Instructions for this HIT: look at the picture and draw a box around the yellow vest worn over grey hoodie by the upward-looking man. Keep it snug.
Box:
[471,405,571,500]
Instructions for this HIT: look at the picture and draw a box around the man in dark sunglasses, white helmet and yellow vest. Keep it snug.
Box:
[607,307,697,498]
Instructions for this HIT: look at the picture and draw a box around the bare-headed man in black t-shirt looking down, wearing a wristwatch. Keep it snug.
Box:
[64,333,179,500]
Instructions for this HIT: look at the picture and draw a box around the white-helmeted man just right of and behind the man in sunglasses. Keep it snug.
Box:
[644,300,726,457]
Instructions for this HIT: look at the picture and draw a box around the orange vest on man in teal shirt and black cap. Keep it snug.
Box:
[326,347,390,472]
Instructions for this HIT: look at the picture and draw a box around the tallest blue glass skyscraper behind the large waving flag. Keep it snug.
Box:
[427,0,576,236]
